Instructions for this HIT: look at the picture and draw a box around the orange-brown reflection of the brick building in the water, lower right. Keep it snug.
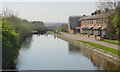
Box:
[81,48,120,70]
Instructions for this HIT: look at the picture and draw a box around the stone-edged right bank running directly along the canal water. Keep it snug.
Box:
[48,32,120,65]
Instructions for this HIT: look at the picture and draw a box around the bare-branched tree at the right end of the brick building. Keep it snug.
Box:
[98,0,119,39]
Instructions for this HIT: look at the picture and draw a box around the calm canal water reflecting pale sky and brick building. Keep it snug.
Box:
[17,34,119,70]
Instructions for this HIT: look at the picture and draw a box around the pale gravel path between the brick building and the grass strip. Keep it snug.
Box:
[62,32,120,50]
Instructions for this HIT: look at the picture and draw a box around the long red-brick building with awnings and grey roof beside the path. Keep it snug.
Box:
[68,15,107,39]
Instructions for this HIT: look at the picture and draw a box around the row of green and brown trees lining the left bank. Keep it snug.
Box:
[0,10,45,69]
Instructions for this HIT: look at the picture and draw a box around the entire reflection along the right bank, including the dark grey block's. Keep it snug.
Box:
[68,43,120,70]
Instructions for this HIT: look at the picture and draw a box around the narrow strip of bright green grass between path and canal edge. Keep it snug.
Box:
[76,40,120,56]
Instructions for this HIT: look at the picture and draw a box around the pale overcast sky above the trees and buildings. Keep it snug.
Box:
[0,2,97,22]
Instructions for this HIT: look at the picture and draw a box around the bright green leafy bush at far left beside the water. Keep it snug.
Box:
[2,18,19,69]
